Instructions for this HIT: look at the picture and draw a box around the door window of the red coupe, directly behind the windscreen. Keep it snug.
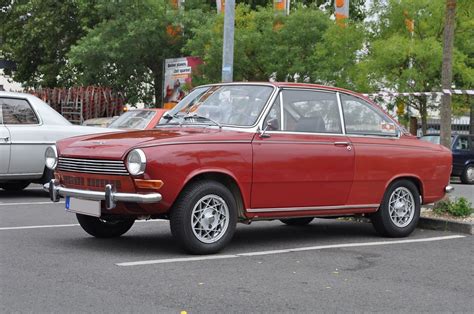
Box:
[281,90,342,133]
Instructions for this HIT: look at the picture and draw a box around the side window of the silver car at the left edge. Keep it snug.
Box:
[0,98,39,124]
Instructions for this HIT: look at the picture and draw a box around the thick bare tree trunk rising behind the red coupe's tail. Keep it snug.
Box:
[440,0,456,148]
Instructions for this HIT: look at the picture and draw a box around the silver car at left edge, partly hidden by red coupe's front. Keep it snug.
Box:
[0,92,114,191]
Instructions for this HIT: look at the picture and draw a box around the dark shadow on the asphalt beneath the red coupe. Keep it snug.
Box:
[51,219,380,260]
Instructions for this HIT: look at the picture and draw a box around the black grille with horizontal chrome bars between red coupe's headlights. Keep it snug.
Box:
[58,157,128,176]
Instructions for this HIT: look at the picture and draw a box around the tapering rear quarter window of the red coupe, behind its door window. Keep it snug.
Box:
[341,94,397,136]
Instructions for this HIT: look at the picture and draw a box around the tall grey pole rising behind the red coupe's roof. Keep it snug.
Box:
[222,0,235,83]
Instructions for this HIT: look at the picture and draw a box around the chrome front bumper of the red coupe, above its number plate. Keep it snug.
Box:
[43,179,161,209]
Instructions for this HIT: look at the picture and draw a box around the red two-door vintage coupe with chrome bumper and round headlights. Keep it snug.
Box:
[45,83,452,254]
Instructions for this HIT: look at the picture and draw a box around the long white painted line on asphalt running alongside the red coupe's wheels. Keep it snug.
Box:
[115,235,466,267]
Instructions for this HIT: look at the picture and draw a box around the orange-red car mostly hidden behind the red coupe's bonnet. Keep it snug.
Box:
[109,108,168,130]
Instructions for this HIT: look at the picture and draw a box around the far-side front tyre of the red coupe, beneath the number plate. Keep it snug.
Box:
[76,214,135,238]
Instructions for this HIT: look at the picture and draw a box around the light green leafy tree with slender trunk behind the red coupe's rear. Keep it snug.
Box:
[357,0,473,133]
